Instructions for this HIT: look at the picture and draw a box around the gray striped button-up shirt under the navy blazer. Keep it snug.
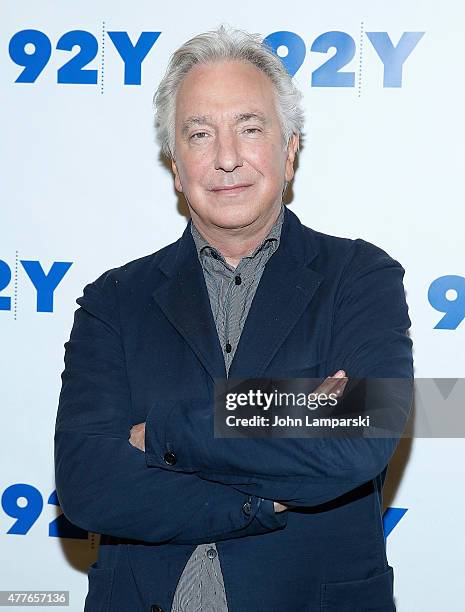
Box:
[171,204,284,612]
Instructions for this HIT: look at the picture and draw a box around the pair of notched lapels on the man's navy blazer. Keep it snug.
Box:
[152,207,323,379]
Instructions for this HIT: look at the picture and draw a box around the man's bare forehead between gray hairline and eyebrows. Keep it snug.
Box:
[176,61,275,122]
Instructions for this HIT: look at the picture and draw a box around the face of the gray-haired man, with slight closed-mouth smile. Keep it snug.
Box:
[172,61,298,228]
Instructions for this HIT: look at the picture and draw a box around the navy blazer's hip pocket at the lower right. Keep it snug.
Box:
[320,565,396,612]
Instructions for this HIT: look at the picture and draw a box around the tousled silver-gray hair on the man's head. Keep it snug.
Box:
[153,25,304,159]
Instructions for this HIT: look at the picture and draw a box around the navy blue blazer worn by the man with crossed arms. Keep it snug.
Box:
[55,208,413,612]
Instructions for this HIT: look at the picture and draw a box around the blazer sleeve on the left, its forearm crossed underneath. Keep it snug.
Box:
[54,270,287,544]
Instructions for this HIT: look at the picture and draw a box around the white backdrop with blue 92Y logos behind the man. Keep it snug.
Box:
[0,0,465,612]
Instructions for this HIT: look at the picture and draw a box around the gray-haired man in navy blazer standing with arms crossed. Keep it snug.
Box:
[55,28,413,612]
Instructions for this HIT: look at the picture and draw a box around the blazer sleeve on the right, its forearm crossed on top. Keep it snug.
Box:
[146,239,413,506]
